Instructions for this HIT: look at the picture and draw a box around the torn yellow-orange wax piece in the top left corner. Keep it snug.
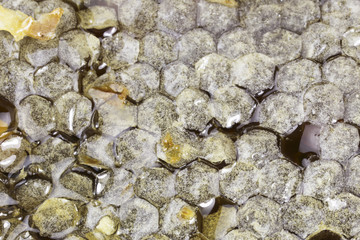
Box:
[0,5,64,41]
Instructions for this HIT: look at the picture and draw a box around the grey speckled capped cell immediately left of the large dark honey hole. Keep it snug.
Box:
[235,129,282,168]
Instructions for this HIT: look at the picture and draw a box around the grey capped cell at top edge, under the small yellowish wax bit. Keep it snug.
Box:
[197,0,239,35]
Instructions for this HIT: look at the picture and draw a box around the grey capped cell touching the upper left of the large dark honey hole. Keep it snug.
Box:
[259,93,305,134]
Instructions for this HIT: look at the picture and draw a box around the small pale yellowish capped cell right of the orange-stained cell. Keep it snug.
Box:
[202,133,236,165]
